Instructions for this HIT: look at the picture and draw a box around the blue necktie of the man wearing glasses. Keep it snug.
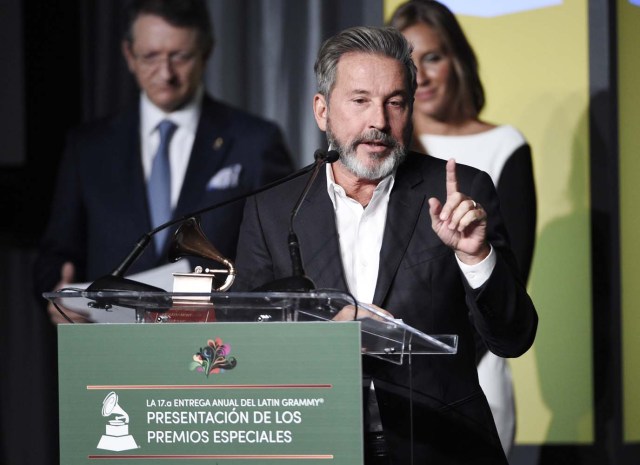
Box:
[147,120,177,254]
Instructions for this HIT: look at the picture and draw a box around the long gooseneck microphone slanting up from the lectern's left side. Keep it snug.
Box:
[87,157,318,292]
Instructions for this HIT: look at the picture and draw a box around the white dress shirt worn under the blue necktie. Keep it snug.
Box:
[140,86,204,208]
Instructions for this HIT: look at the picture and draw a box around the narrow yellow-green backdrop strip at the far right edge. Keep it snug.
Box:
[618,0,640,442]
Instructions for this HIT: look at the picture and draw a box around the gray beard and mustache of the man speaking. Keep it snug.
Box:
[327,122,407,181]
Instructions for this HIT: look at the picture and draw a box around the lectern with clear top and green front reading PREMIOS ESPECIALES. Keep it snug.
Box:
[44,290,457,465]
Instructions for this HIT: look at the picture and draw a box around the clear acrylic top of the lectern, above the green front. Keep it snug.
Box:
[43,289,458,364]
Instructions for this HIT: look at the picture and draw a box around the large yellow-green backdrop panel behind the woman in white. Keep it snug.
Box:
[385,0,592,444]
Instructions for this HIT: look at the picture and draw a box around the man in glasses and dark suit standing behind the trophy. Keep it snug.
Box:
[35,0,293,319]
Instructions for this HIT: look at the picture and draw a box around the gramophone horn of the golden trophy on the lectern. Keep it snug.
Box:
[168,217,236,291]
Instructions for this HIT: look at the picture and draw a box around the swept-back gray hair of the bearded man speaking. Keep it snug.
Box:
[313,26,416,101]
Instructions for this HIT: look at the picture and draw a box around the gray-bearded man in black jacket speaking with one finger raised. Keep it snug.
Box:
[236,28,537,465]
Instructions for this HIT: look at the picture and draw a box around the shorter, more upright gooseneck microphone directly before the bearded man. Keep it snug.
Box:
[255,149,340,292]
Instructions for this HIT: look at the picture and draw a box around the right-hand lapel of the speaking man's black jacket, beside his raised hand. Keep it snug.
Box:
[373,169,428,306]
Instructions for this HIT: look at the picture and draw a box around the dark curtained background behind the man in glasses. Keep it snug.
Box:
[0,0,382,465]
